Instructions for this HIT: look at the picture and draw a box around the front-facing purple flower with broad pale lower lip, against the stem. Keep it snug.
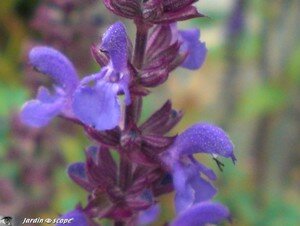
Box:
[73,22,130,130]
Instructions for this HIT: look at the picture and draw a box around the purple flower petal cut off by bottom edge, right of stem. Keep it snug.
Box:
[171,202,229,226]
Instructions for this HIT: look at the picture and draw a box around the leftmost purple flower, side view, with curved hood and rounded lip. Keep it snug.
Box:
[21,47,78,127]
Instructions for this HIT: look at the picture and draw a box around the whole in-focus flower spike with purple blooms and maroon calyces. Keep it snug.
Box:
[21,0,236,226]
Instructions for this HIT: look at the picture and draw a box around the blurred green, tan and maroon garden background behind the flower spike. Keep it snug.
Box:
[0,0,300,226]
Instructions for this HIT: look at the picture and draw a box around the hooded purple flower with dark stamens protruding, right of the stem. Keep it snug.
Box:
[163,123,236,212]
